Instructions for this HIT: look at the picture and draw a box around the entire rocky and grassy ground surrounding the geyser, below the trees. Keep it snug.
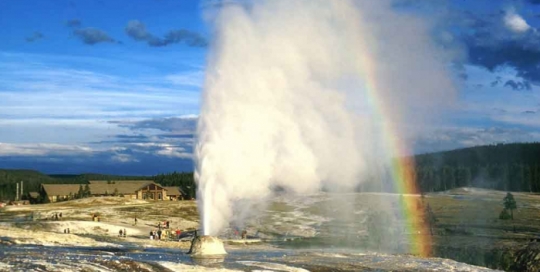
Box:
[0,188,540,271]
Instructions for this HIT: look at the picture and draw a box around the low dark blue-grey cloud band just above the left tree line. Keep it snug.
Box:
[0,143,193,175]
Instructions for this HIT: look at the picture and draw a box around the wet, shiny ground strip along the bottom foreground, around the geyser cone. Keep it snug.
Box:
[0,242,498,271]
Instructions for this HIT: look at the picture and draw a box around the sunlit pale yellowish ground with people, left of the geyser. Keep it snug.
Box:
[0,197,199,248]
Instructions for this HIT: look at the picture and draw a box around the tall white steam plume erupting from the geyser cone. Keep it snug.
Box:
[196,0,453,235]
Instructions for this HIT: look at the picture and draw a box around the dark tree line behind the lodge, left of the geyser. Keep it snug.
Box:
[0,169,197,201]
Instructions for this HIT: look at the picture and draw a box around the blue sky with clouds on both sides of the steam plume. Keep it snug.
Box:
[0,0,540,175]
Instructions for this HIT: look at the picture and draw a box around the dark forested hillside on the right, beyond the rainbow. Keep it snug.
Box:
[414,143,540,192]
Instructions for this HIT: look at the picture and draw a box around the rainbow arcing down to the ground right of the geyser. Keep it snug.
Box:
[359,38,432,257]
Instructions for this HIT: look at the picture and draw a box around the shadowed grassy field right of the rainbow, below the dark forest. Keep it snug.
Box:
[427,189,540,243]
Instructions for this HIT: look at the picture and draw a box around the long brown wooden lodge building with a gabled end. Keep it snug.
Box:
[40,180,184,202]
